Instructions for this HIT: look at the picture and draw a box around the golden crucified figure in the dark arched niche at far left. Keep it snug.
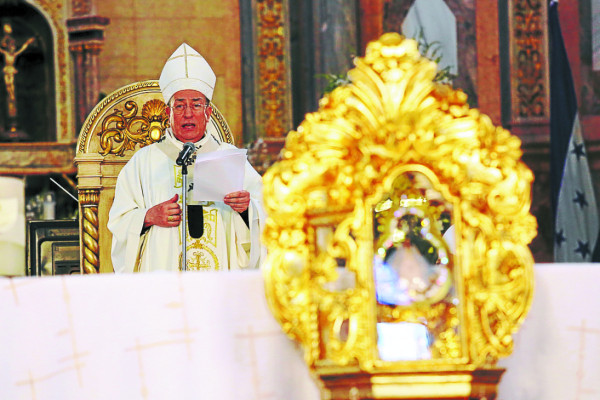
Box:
[0,24,34,141]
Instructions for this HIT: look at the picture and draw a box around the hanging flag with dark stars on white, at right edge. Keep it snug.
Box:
[548,1,599,262]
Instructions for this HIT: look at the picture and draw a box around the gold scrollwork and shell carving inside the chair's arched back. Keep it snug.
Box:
[98,99,169,156]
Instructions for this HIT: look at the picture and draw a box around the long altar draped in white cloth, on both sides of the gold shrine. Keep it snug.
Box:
[0,264,600,400]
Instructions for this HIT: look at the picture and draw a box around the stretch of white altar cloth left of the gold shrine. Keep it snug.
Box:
[0,271,319,400]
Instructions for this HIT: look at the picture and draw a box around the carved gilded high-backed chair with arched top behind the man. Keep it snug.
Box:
[75,80,233,274]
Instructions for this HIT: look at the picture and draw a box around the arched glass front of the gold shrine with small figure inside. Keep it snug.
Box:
[373,168,462,361]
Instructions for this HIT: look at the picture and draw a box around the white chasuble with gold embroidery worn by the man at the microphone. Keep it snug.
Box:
[108,130,266,272]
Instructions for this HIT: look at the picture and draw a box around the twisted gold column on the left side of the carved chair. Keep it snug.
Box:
[79,189,100,274]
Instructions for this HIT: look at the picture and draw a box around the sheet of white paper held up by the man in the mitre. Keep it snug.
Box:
[192,149,246,201]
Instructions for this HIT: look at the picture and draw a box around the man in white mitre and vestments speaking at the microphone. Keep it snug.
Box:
[108,43,266,272]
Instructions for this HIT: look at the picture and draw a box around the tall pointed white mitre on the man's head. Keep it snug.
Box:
[158,43,217,104]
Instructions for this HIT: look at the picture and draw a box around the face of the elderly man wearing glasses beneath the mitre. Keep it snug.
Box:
[169,89,212,142]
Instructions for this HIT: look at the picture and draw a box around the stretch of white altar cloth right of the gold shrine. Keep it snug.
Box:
[498,264,600,400]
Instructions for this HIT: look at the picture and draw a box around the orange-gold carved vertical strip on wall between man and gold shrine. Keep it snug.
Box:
[256,0,291,137]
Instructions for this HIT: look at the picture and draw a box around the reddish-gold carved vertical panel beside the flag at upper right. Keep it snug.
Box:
[509,0,549,121]
